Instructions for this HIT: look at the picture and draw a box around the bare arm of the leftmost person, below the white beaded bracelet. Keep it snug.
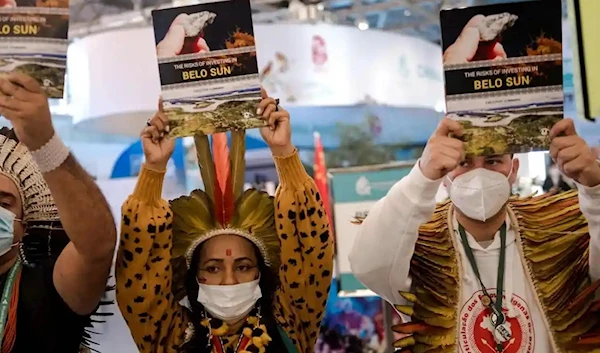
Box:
[44,156,117,314]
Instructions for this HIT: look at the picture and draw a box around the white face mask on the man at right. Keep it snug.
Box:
[448,168,512,222]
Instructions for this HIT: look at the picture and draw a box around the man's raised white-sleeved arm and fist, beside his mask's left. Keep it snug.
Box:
[349,119,464,304]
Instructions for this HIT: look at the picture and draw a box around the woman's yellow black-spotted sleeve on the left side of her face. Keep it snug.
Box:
[115,167,188,353]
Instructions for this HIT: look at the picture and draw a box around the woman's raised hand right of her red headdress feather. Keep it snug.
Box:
[256,88,296,156]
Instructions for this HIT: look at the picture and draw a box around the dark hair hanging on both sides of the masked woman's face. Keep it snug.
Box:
[182,239,278,353]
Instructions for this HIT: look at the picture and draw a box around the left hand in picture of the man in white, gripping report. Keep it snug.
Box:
[419,118,465,180]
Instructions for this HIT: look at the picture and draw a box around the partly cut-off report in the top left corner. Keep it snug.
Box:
[0,0,69,99]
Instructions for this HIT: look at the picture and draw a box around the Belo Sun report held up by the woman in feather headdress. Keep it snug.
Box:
[152,0,266,137]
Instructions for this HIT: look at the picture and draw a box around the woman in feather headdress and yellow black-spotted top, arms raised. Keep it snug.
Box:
[116,91,333,353]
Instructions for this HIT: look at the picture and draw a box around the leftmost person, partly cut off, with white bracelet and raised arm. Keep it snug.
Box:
[0,73,116,353]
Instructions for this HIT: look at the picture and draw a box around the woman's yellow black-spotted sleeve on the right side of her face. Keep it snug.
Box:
[275,153,333,353]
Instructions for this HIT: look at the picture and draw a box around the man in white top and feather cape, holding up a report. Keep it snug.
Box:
[349,119,600,353]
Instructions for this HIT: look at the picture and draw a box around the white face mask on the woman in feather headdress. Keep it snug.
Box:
[198,279,262,322]
